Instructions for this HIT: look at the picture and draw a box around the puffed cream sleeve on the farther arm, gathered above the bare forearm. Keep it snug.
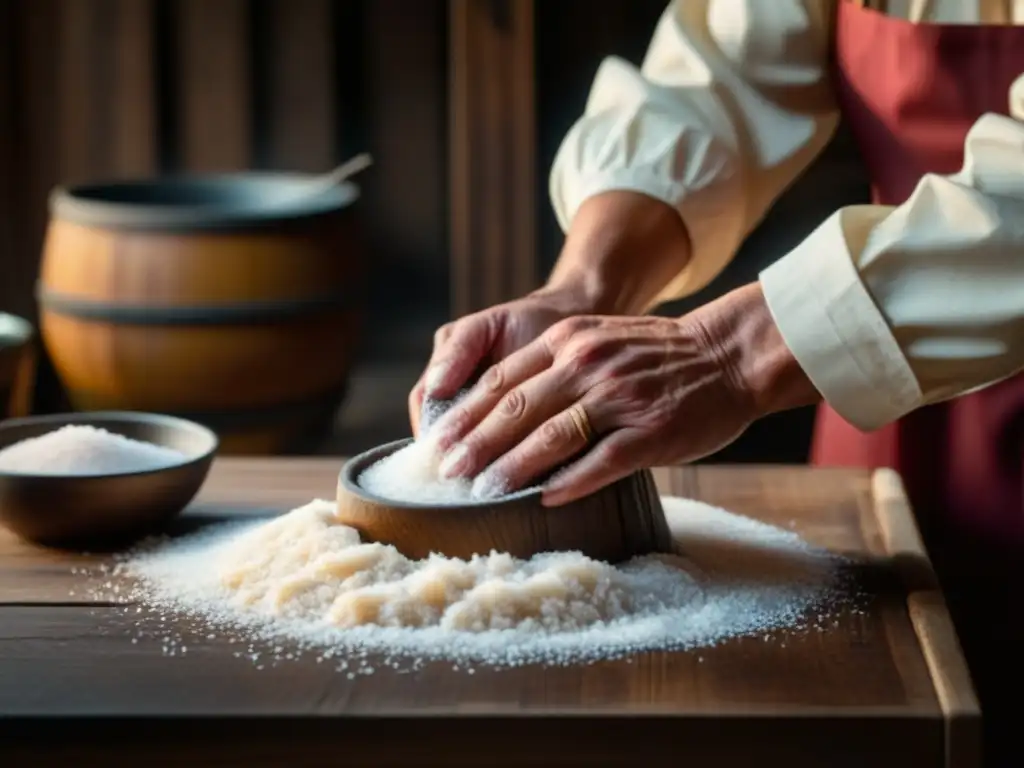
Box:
[550,0,838,302]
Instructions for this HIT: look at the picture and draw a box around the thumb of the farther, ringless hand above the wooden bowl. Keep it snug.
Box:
[423,310,502,400]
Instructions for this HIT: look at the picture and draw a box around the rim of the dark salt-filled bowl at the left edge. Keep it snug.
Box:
[0,411,220,482]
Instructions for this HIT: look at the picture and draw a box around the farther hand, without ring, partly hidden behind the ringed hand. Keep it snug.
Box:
[409,291,586,435]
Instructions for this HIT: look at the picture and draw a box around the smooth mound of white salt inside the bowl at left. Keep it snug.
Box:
[0,424,185,475]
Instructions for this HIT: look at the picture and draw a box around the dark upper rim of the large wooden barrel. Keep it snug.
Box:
[49,171,359,231]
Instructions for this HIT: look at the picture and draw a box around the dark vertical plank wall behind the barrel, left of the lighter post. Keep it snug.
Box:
[0,0,449,346]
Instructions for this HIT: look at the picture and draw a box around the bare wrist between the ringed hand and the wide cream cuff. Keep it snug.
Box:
[691,283,821,419]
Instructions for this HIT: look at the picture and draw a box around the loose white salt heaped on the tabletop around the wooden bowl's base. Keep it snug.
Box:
[105,497,839,671]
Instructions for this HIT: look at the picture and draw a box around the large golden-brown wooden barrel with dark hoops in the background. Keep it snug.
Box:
[38,173,364,454]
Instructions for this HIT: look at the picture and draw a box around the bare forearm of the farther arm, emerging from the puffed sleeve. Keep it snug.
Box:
[542,190,690,314]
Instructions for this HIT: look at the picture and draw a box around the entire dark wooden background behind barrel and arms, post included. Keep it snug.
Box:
[0,0,867,462]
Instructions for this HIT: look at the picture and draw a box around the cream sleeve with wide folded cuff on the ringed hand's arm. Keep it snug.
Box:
[761,85,1024,430]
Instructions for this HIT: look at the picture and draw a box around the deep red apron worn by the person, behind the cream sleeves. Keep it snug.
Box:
[812,2,1024,765]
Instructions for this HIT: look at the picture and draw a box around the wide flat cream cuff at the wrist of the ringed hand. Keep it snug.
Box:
[761,211,923,431]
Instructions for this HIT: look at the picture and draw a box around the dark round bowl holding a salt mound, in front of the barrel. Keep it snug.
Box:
[0,413,217,551]
